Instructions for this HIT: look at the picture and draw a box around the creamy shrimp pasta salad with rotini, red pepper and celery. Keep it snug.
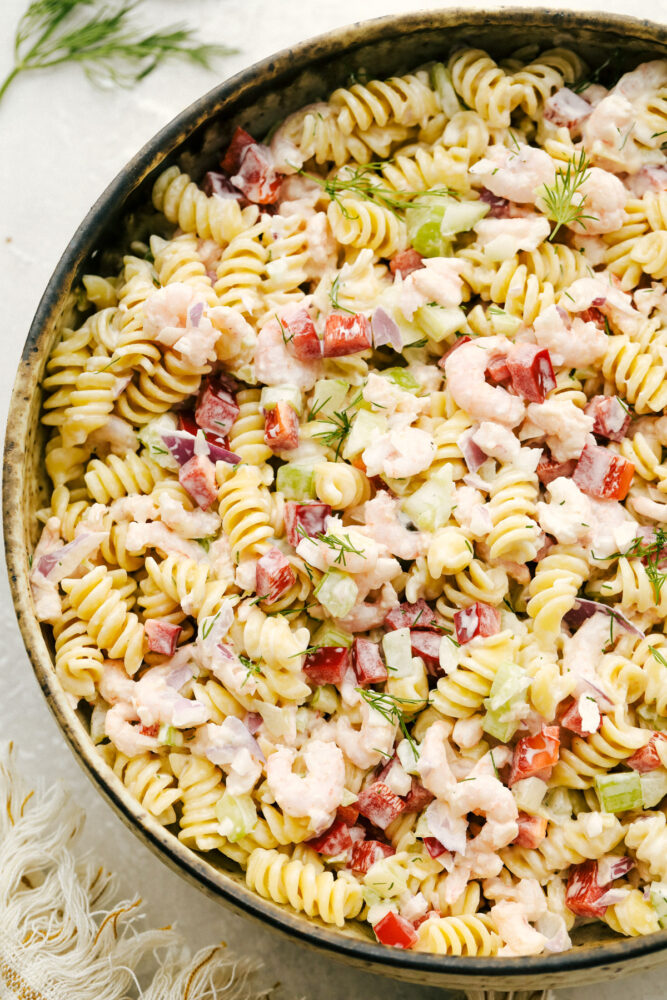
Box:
[31,48,667,956]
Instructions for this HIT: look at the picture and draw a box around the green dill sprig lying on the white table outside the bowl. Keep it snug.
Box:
[0,0,235,100]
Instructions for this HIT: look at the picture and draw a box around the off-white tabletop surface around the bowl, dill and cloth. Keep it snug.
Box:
[0,0,667,1000]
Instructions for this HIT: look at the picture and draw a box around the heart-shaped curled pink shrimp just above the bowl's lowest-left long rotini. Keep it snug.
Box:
[266,740,345,833]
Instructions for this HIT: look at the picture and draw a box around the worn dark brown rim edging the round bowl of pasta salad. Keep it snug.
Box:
[3,7,667,986]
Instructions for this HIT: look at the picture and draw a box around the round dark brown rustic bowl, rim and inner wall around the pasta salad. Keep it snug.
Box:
[3,8,667,990]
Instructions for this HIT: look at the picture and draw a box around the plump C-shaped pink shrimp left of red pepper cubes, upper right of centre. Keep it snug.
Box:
[446,337,526,426]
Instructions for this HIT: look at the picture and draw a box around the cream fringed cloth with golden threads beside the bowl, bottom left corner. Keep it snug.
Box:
[0,744,265,1000]
